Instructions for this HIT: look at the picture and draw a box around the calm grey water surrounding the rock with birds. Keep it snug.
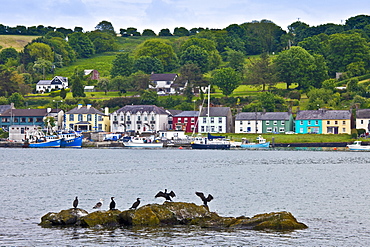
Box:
[0,149,370,246]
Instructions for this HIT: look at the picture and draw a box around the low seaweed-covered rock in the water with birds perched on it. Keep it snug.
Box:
[40,202,307,230]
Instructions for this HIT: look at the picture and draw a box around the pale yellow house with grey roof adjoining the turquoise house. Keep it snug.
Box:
[322,110,352,135]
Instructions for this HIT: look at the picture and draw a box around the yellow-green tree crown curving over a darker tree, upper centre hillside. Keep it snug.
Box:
[135,39,178,71]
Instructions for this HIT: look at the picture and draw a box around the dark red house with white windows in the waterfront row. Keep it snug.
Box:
[172,111,199,132]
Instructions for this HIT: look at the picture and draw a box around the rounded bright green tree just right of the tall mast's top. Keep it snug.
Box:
[212,68,240,96]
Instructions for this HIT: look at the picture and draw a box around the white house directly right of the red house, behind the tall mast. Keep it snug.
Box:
[198,107,233,133]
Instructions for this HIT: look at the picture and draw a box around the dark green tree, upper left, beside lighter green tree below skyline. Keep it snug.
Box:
[68,33,95,58]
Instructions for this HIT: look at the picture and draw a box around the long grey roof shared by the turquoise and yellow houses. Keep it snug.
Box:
[296,110,351,120]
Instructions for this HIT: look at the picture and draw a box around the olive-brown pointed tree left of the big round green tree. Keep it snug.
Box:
[247,53,277,91]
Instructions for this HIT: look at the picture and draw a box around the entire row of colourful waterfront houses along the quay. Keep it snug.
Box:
[0,105,370,134]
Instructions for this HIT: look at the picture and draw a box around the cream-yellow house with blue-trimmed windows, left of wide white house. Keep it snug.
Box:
[64,104,110,132]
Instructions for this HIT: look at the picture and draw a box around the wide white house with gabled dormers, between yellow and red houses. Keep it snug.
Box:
[111,105,168,133]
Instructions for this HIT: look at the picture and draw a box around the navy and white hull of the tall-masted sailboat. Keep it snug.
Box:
[190,133,231,149]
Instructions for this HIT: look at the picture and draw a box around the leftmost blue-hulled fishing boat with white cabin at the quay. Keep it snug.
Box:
[23,130,61,148]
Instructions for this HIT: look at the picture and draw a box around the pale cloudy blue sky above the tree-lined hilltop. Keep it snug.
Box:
[0,0,370,34]
